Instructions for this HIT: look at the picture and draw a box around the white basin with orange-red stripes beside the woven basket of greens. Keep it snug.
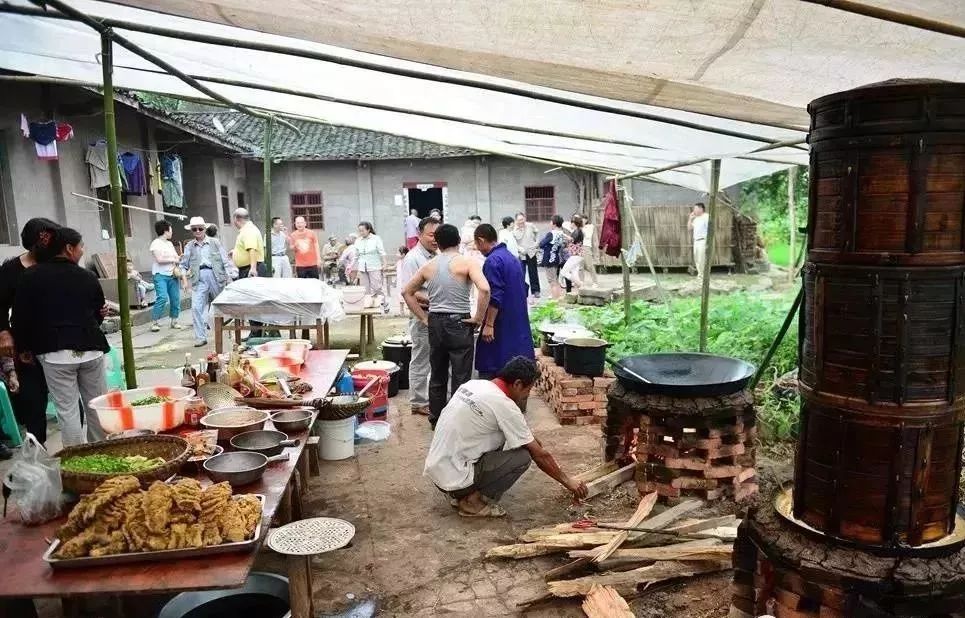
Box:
[90,386,194,434]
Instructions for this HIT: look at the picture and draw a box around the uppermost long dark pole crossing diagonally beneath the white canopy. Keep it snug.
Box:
[0,0,799,144]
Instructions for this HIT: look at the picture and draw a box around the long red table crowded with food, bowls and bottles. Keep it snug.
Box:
[0,340,348,615]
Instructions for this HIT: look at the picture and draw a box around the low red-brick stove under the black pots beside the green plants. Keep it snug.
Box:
[536,350,616,425]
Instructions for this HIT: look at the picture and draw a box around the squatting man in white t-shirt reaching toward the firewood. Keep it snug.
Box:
[425,356,587,517]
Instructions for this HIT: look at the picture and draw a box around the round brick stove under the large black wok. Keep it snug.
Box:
[604,382,758,503]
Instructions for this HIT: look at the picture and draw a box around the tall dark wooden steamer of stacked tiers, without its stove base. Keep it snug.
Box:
[794,82,965,547]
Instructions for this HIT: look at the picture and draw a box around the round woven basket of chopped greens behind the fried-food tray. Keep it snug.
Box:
[56,435,191,495]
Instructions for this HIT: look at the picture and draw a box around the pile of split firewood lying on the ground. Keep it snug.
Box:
[486,488,739,618]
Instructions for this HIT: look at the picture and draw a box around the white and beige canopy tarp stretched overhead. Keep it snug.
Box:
[0,0,965,191]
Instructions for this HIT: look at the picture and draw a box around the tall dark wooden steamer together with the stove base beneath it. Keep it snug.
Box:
[730,81,965,618]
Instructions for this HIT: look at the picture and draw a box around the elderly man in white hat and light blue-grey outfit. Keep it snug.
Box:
[181,217,237,348]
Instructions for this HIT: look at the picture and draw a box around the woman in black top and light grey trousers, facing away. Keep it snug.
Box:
[13,228,110,446]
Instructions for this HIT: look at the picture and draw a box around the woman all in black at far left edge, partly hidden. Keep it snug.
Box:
[0,218,60,444]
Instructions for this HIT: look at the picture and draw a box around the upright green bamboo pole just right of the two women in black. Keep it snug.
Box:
[101,28,137,388]
